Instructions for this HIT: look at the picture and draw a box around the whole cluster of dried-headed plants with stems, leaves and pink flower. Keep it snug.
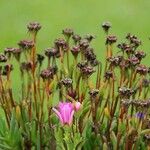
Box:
[0,22,150,150]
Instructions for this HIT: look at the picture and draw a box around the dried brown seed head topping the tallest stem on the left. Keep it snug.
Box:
[27,22,41,33]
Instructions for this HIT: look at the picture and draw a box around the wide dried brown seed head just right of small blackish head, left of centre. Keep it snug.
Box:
[45,47,59,58]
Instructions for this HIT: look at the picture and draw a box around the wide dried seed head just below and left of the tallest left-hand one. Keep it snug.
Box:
[18,40,34,50]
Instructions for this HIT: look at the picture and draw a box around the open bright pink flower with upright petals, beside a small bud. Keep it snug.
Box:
[53,102,74,125]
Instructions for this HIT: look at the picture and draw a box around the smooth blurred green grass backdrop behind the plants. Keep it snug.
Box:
[0,0,150,96]
